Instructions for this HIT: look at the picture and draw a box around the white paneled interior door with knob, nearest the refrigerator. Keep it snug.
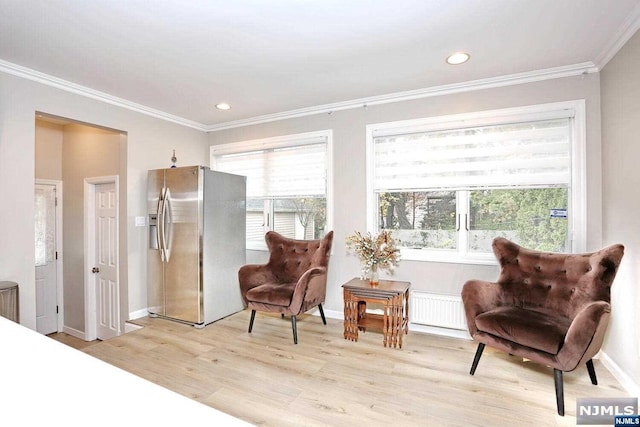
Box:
[92,183,120,340]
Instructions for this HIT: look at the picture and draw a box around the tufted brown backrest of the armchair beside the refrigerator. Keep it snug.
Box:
[265,231,333,283]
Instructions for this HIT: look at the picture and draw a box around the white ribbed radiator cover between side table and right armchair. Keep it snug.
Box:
[409,291,467,331]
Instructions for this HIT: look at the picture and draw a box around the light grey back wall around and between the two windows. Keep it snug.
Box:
[209,74,602,312]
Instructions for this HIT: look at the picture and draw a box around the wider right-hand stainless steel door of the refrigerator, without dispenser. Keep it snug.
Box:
[163,166,204,323]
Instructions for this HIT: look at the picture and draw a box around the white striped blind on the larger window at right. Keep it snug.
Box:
[373,118,572,192]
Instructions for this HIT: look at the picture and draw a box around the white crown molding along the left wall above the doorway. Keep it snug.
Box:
[0,59,207,132]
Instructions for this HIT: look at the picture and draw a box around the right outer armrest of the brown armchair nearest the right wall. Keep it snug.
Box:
[557,301,611,372]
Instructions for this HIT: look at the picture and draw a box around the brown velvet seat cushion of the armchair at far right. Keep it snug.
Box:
[475,306,571,355]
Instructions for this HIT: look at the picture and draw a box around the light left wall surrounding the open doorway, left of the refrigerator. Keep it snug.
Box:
[0,73,208,329]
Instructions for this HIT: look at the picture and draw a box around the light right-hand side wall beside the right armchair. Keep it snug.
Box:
[602,29,640,396]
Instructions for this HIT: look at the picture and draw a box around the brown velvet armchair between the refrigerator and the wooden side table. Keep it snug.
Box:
[238,231,333,344]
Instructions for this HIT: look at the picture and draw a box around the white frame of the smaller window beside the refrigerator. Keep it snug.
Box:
[209,129,333,251]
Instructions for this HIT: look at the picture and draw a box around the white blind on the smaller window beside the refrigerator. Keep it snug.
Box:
[212,133,327,198]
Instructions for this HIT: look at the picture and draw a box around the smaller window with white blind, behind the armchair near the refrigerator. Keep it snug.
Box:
[211,130,332,249]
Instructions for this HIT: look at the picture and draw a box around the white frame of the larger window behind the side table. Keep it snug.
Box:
[366,100,587,264]
